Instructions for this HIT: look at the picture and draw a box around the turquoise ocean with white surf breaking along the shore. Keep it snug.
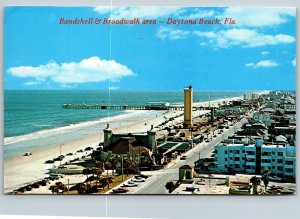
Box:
[4,90,245,158]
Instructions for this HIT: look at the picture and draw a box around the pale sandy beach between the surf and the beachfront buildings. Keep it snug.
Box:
[4,97,246,193]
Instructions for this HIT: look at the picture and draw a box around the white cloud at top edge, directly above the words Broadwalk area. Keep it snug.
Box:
[94,6,184,19]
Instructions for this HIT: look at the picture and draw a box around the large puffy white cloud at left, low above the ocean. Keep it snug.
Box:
[8,56,134,85]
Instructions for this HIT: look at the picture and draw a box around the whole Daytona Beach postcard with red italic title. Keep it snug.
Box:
[3,6,296,195]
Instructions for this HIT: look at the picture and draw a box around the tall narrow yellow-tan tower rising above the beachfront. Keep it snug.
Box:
[183,86,193,128]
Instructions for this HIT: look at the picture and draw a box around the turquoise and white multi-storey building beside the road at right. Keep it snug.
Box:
[215,140,296,179]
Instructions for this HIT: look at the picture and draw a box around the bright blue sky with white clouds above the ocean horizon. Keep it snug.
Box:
[4,7,296,90]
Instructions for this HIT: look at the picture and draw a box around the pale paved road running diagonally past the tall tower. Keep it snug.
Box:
[129,119,247,194]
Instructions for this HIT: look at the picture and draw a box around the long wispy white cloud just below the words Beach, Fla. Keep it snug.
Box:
[193,29,295,48]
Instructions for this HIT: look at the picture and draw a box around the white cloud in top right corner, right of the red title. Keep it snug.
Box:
[220,7,296,27]
